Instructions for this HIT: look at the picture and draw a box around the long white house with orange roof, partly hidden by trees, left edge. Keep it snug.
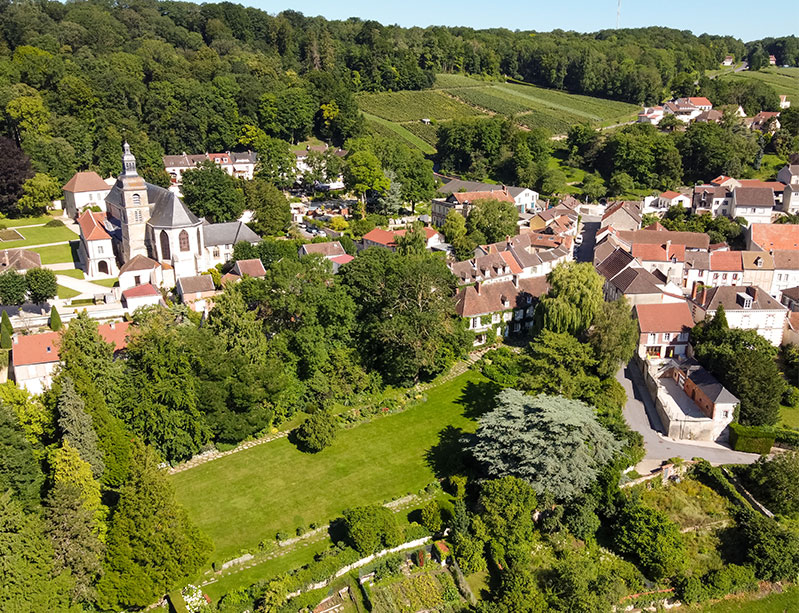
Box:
[9,322,130,394]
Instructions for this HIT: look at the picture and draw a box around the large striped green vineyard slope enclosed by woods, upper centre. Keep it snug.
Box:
[357,74,640,153]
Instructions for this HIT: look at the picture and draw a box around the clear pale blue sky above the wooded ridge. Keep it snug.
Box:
[248,0,798,41]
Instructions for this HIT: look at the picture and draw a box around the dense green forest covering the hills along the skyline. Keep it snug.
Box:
[0,0,799,191]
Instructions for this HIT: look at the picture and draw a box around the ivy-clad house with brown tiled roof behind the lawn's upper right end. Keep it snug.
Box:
[455,277,549,347]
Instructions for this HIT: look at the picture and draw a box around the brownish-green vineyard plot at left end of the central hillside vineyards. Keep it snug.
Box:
[358,89,482,122]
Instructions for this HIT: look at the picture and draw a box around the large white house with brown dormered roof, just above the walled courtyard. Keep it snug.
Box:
[691,286,787,347]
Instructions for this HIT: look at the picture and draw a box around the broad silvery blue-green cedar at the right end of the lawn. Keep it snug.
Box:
[472,389,621,500]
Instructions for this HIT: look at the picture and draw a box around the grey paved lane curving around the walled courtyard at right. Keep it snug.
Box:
[616,365,760,474]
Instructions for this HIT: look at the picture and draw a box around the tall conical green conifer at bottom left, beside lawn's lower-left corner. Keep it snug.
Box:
[97,442,211,609]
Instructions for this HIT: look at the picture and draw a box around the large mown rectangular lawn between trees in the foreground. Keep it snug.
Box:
[171,372,488,559]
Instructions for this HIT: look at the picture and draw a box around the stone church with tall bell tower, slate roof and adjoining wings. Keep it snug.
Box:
[78,143,261,290]
